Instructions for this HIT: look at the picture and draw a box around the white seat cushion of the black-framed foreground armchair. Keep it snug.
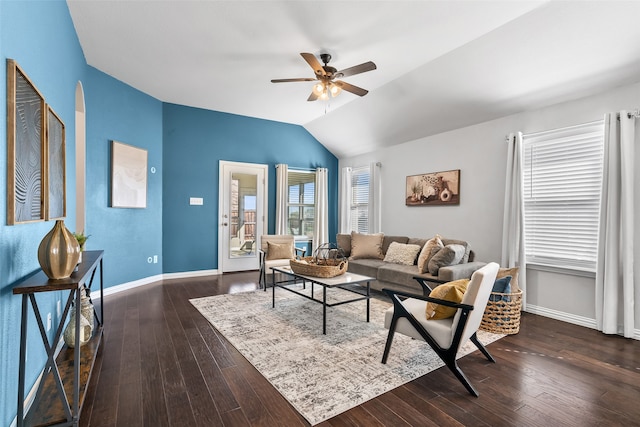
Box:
[384,298,453,348]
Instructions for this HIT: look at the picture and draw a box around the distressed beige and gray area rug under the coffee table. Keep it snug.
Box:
[190,285,502,425]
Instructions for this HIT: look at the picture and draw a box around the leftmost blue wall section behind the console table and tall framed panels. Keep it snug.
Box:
[0,1,86,426]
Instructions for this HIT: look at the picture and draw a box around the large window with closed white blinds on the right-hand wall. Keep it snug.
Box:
[523,121,604,271]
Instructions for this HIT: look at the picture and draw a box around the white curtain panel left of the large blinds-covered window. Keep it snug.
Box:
[501,132,527,310]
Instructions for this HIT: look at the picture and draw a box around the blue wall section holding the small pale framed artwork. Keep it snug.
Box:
[84,67,163,287]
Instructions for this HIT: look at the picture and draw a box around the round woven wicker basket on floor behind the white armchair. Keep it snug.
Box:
[480,290,522,335]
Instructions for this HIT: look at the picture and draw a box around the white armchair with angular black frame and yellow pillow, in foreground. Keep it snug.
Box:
[382,262,499,397]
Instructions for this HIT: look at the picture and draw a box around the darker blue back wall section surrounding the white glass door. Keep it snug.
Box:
[163,104,338,273]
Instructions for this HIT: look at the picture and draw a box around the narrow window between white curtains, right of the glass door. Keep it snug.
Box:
[287,170,316,239]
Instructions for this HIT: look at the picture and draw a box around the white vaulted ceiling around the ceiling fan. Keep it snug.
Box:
[67,0,640,157]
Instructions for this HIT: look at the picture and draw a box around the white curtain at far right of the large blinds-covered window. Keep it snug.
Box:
[596,111,635,338]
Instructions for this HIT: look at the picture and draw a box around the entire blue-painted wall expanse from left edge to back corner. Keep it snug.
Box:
[0,0,338,426]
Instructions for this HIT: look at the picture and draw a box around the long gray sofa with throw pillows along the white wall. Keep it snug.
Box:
[336,234,486,294]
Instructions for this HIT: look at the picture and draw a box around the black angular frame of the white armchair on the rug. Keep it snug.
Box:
[382,277,496,397]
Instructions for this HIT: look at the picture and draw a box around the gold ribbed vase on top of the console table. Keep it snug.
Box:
[38,219,80,280]
